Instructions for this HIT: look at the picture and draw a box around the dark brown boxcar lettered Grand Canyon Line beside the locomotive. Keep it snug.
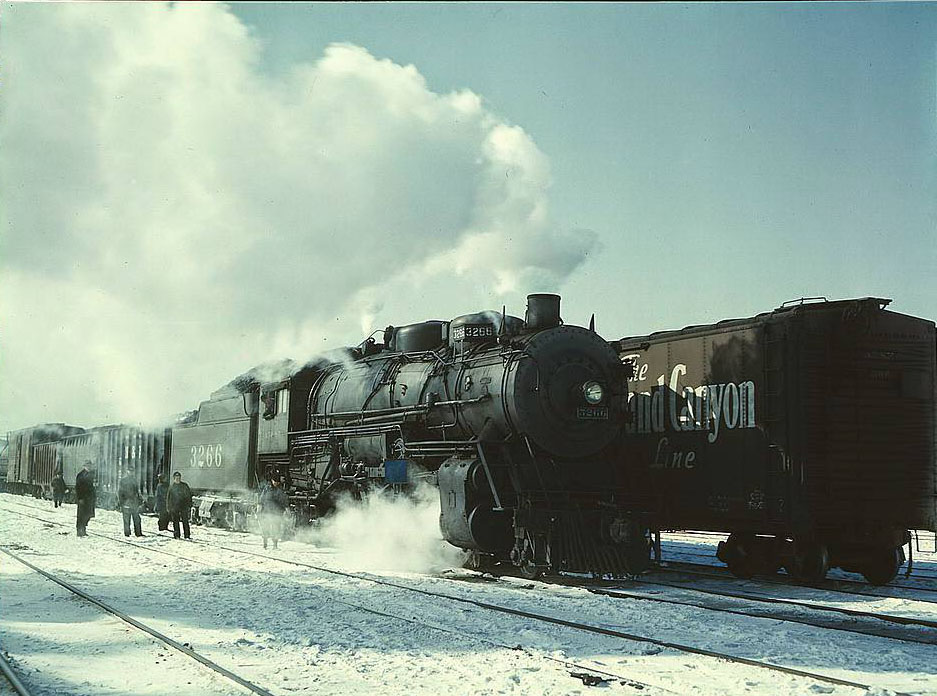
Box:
[613,298,937,584]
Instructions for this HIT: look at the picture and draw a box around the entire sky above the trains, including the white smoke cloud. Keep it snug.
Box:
[0,3,937,431]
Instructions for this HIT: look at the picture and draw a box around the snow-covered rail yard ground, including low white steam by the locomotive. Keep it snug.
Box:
[0,495,937,696]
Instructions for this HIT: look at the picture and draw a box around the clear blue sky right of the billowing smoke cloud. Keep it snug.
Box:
[233,3,937,333]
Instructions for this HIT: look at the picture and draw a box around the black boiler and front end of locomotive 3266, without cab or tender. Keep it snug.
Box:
[289,294,648,575]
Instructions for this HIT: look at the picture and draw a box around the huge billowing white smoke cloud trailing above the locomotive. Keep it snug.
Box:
[0,3,596,427]
